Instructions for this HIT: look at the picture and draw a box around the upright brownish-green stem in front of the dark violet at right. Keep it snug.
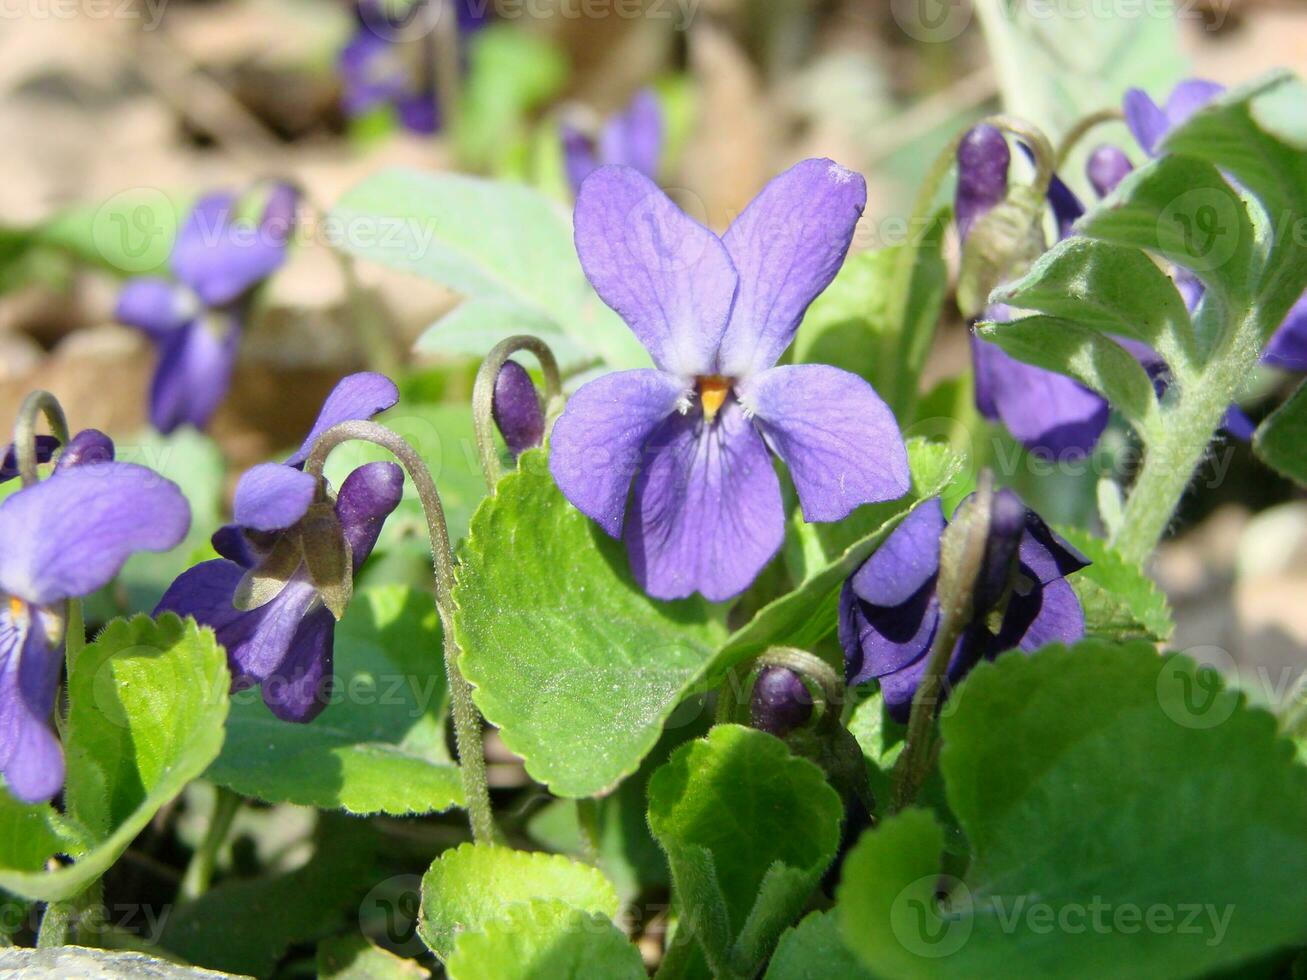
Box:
[893,470,993,813]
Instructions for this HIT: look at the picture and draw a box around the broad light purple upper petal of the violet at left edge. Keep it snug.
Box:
[0,463,191,605]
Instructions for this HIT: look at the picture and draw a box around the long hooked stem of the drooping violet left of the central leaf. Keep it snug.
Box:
[305,421,497,841]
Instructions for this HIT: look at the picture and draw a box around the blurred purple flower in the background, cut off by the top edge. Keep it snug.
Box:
[336,0,490,136]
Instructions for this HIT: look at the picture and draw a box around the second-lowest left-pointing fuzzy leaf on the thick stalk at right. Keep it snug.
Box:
[991,235,1196,375]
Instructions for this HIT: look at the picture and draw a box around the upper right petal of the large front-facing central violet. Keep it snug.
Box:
[716,159,867,378]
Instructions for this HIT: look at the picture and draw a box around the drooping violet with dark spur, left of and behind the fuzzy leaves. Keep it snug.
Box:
[955,125,1108,457]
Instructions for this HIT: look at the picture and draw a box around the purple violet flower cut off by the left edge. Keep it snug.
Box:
[0,439,191,804]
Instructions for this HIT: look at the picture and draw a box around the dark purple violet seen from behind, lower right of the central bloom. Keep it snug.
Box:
[839,489,1089,721]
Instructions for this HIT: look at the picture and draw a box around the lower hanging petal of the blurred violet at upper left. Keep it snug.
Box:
[150,314,240,435]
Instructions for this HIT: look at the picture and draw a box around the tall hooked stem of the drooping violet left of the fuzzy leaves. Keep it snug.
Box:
[881,115,1055,422]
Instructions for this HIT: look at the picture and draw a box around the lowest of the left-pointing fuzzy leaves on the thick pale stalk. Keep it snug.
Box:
[976,315,1158,440]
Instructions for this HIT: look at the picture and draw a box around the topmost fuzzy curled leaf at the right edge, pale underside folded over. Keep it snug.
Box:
[1165,71,1307,328]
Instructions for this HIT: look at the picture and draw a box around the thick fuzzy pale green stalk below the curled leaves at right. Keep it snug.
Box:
[1112,306,1264,563]
